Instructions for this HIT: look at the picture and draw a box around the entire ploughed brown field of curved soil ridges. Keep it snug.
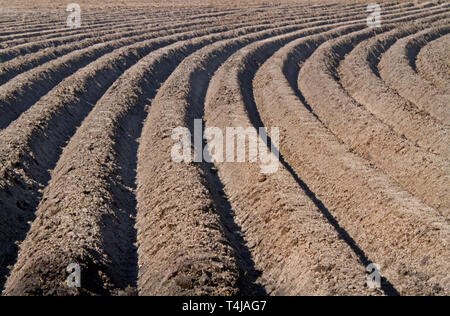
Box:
[0,0,450,295]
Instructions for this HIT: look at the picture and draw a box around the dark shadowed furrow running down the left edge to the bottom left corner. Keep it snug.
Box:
[0,49,150,291]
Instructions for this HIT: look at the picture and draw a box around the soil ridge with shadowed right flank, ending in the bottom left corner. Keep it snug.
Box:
[4,27,251,295]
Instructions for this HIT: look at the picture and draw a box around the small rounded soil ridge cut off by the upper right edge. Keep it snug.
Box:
[416,34,450,94]
